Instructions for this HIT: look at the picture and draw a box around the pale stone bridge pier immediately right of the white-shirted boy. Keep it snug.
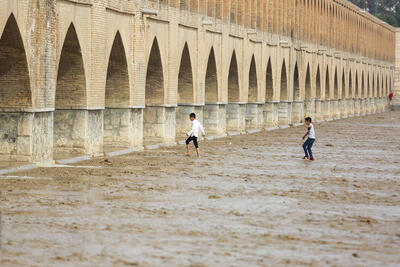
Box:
[203,103,226,136]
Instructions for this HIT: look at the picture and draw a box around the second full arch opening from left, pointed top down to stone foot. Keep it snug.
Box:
[54,23,87,157]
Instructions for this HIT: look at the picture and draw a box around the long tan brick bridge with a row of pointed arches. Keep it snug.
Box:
[0,0,396,162]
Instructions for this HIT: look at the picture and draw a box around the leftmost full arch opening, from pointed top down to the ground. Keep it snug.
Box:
[0,14,33,156]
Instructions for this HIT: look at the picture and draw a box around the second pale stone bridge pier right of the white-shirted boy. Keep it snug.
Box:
[226,103,246,134]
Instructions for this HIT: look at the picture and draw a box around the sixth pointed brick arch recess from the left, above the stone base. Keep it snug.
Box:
[205,47,218,103]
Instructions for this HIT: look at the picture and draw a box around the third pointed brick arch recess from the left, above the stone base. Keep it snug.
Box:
[105,31,129,108]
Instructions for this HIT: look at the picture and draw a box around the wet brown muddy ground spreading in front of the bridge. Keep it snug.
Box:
[0,112,400,266]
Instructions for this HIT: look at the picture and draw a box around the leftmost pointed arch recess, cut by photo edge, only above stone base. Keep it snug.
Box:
[0,14,32,110]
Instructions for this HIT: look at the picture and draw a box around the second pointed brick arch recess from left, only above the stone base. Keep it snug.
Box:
[55,23,87,109]
